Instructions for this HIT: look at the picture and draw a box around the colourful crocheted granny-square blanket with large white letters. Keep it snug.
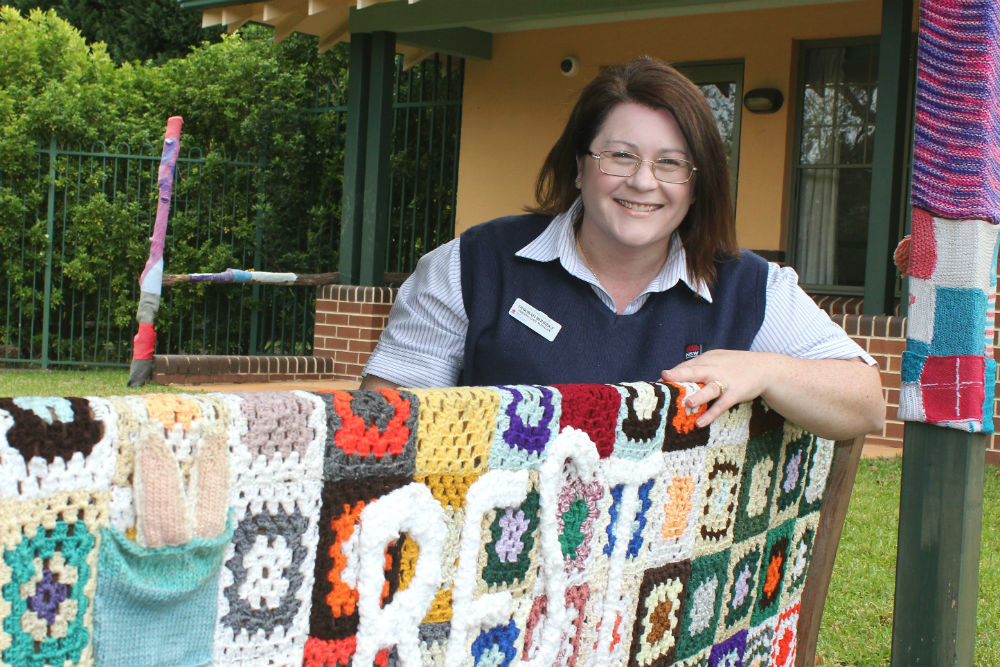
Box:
[0,383,834,667]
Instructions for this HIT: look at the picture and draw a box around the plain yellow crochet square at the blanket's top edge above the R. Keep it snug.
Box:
[411,387,500,475]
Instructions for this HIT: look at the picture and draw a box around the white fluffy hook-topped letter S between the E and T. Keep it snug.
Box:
[521,426,600,667]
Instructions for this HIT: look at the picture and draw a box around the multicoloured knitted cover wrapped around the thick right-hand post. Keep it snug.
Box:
[896,0,1000,433]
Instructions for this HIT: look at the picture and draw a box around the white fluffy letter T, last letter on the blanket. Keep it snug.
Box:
[594,452,663,667]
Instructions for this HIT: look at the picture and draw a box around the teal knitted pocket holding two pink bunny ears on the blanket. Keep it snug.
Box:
[94,520,233,667]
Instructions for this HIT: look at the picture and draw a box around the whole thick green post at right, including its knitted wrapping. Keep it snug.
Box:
[892,0,1000,667]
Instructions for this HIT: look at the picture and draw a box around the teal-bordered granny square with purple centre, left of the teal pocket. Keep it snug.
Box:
[2,521,96,667]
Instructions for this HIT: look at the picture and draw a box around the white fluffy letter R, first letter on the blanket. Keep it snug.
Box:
[353,482,448,667]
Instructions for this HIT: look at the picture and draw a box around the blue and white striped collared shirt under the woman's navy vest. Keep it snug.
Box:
[364,200,875,387]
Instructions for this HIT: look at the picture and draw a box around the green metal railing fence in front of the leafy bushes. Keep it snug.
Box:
[0,57,463,367]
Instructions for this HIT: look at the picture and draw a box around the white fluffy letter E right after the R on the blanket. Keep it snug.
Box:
[444,470,528,667]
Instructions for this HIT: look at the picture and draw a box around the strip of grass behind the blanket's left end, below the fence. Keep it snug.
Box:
[0,368,188,396]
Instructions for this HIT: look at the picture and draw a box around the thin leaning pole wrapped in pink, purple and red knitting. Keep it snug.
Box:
[128,116,184,387]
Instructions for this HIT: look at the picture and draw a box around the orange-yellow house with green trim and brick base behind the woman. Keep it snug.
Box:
[181,0,1000,462]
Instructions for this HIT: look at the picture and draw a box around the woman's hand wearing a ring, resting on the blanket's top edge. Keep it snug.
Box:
[661,350,768,427]
